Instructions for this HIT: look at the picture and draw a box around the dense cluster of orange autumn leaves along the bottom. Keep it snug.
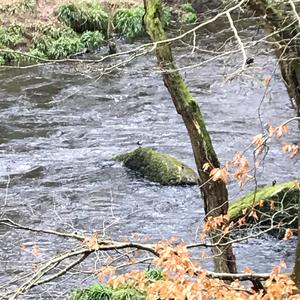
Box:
[98,242,299,300]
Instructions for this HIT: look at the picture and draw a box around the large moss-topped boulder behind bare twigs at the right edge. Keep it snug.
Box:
[229,181,300,233]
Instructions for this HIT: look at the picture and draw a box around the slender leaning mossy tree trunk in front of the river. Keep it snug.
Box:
[144,0,236,273]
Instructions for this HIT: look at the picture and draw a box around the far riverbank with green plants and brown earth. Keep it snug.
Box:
[0,0,197,65]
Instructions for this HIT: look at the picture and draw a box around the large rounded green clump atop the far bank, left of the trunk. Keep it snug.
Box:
[57,2,108,35]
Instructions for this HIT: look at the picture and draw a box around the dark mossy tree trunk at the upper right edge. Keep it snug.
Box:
[247,0,300,127]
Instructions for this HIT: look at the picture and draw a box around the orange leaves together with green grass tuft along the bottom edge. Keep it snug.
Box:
[71,241,296,300]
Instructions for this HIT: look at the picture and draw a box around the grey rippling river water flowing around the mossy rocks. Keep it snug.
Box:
[0,32,300,299]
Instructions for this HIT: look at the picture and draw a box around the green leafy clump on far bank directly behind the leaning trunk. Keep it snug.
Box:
[113,5,171,39]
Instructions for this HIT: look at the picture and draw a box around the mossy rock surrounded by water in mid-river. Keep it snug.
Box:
[114,147,197,185]
